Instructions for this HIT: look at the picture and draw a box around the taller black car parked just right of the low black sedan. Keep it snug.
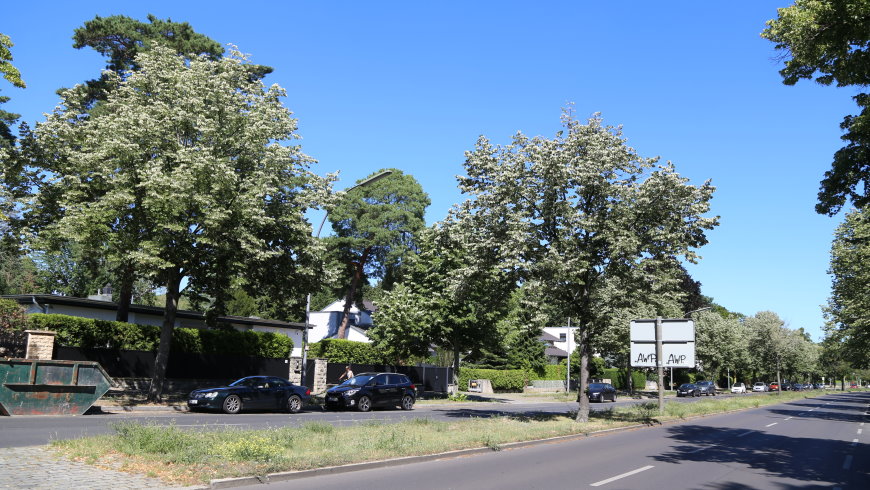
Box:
[324,373,417,412]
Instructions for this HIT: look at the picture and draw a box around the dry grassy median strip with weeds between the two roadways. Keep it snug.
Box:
[52,392,860,485]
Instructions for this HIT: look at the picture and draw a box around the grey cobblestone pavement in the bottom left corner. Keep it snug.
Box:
[0,446,199,490]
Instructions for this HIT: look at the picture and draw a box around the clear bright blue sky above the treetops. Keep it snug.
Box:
[0,0,854,340]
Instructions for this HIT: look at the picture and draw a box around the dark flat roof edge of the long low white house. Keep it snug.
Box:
[0,294,305,330]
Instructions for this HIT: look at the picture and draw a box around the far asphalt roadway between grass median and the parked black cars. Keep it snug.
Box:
[0,395,728,447]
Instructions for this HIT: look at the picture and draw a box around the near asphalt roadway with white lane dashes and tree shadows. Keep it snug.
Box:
[238,392,870,490]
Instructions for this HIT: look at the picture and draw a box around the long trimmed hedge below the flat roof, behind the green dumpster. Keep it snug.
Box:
[28,313,293,358]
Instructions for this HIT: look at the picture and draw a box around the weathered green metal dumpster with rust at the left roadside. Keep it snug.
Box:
[0,359,112,415]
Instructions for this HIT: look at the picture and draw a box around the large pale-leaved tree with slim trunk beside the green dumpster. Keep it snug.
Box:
[37,45,326,397]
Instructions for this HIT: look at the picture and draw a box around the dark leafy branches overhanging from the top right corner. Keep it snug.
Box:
[761,0,870,212]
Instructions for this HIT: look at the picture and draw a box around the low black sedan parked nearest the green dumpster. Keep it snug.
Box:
[187,376,311,414]
